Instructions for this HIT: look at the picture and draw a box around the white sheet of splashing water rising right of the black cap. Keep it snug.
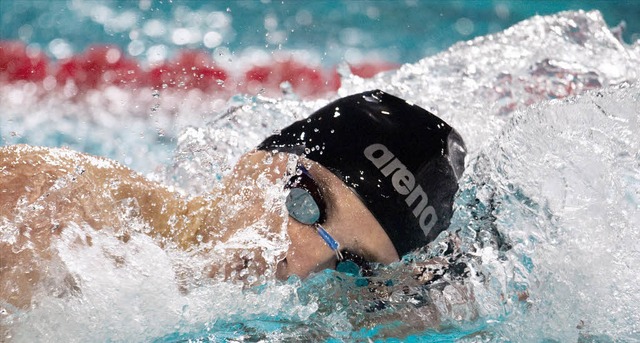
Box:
[453,83,640,342]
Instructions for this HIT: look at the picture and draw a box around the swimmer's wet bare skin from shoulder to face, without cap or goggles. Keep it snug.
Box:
[0,146,399,308]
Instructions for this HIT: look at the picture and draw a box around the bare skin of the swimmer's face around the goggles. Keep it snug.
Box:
[226,151,399,279]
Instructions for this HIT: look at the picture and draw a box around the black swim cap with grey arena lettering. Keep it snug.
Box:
[258,90,466,256]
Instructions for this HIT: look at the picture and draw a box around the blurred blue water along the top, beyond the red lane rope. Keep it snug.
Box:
[0,0,640,65]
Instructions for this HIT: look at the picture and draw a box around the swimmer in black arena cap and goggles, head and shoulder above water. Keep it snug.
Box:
[0,90,466,318]
